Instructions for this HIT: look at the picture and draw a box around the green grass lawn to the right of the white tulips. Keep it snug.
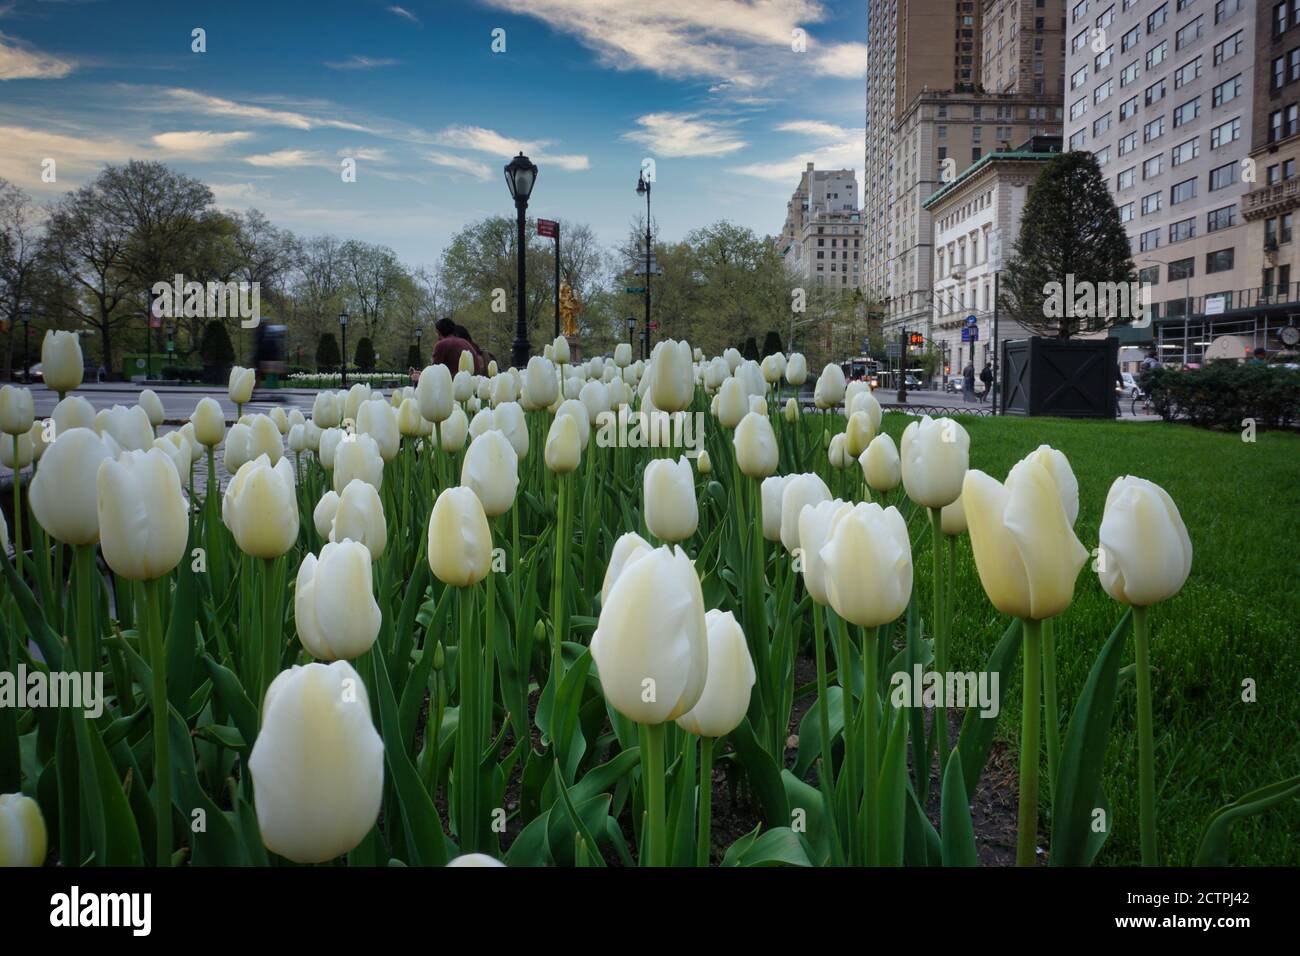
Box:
[884,415,1300,866]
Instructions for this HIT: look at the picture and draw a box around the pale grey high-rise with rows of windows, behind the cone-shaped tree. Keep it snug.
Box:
[1066,0,1268,326]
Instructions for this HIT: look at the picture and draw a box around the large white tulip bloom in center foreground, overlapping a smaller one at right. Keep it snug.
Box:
[592,548,709,724]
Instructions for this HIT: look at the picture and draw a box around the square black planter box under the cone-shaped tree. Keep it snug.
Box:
[1001,337,1119,419]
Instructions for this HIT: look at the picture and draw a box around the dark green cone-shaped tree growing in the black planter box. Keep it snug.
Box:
[998,151,1138,338]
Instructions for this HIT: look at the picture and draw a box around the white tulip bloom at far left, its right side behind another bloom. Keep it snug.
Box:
[27,428,118,545]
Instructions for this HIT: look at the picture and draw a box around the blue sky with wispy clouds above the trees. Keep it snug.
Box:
[0,0,866,265]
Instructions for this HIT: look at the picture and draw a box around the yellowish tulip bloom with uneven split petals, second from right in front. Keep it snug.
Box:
[967,459,1088,620]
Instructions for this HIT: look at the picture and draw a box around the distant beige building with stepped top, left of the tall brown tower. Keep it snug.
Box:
[776,163,862,291]
